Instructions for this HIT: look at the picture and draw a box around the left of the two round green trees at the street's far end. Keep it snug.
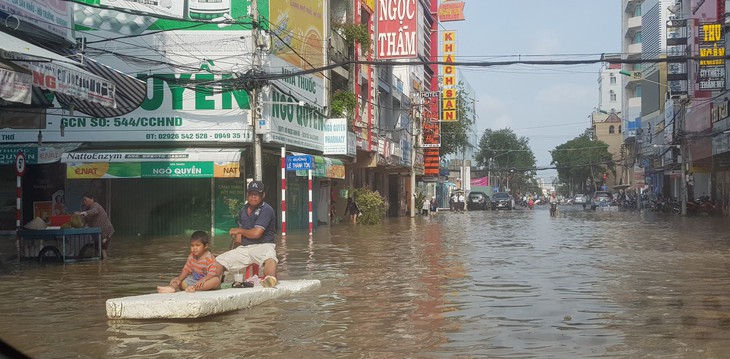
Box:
[475,128,537,193]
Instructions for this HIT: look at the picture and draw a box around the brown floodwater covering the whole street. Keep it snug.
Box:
[0,206,730,358]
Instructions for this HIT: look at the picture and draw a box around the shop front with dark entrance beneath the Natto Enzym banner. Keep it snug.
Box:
[61,148,245,235]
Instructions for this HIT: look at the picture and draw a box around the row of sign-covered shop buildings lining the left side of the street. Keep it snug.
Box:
[0,0,446,235]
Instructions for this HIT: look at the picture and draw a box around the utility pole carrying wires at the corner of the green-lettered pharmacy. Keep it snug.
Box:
[249,0,263,181]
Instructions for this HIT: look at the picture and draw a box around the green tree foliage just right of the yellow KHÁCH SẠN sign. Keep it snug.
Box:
[439,82,475,156]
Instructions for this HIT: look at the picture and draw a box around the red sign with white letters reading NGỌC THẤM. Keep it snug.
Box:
[376,0,418,60]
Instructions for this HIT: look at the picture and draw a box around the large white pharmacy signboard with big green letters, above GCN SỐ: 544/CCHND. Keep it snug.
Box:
[0,1,258,146]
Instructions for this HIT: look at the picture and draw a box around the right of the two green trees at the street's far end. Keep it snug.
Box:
[552,131,616,194]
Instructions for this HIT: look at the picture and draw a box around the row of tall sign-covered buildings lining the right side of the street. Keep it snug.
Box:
[622,0,730,214]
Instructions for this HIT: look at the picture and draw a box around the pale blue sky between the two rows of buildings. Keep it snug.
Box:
[440,0,622,181]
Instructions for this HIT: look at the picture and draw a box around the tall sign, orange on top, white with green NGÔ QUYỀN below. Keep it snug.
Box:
[262,0,327,151]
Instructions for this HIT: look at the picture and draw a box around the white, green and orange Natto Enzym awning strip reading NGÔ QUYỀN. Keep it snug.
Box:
[61,148,241,179]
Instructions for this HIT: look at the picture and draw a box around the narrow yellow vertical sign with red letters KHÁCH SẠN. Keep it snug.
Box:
[441,31,459,122]
